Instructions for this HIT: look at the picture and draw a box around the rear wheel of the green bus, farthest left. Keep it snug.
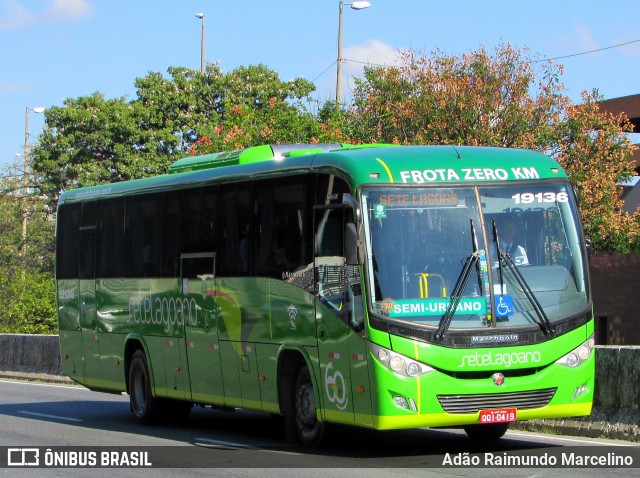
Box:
[129,350,161,424]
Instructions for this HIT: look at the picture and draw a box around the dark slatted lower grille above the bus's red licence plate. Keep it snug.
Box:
[437,388,557,413]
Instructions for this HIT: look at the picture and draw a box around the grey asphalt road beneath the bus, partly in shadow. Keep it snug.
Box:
[0,380,640,478]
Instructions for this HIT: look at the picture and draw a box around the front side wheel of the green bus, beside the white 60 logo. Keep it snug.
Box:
[293,366,326,446]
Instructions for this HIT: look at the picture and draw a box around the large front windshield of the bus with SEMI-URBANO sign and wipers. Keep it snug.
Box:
[363,182,589,330]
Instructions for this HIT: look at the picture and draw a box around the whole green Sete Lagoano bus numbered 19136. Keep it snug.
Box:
[56,144,595,445]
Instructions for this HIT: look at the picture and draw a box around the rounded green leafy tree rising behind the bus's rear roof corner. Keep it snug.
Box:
[31,93,168,205]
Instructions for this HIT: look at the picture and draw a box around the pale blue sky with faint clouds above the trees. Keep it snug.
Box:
[0,0,640,167]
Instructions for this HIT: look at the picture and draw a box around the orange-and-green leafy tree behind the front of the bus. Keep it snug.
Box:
[340,45,640,252]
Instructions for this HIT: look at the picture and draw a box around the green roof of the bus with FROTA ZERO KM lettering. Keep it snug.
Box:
[60,144,567,203]
